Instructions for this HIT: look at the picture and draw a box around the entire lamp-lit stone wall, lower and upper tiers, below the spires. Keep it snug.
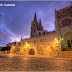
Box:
[10,32,61,56]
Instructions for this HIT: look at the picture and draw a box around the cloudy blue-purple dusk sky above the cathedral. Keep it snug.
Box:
[0,1,71,46]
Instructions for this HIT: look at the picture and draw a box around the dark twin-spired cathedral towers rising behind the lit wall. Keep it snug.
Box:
[30,12,47,37]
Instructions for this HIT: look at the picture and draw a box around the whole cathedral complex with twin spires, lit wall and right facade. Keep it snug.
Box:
[10,5,72,56]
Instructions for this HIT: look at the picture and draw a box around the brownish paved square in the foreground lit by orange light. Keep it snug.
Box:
[0,55,72,71]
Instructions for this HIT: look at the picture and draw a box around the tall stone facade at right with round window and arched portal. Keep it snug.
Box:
[55,5,72,48]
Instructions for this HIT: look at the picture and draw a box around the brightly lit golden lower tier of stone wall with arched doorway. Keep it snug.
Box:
[10,43,61,56]
